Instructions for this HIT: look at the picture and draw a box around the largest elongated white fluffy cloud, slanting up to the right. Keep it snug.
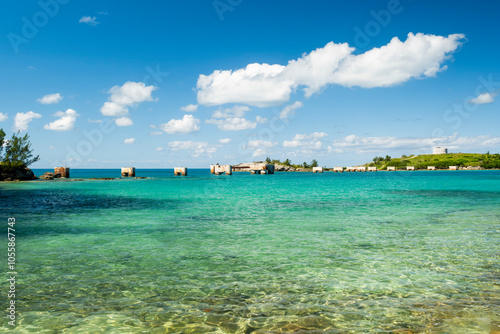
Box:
[197,33,465,107]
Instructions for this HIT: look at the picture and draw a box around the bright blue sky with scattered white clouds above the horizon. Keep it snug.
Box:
[0,0,500,168]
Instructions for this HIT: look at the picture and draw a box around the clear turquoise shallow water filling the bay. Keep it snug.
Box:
[0,170,500,334]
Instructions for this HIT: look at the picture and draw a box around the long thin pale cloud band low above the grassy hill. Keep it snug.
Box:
[328,133,500,154]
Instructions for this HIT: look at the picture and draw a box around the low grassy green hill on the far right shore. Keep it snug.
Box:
[364,153,500,170]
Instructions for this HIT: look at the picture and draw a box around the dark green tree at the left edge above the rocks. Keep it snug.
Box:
[0,129,40,171]
